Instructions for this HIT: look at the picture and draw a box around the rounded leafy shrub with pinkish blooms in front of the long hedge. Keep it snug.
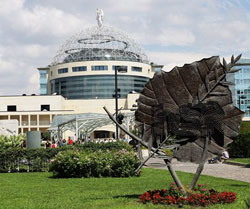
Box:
[50,149,140,178]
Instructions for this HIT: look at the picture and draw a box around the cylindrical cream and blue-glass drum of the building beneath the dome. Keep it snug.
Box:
[48,61,152,99]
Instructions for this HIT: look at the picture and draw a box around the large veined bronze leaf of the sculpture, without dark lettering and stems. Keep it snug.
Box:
[136,56,243,162]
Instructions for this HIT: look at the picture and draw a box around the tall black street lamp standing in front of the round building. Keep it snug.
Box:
[113,66,128,139]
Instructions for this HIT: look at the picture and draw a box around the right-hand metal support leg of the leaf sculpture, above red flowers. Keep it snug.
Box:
[188,133,210,190]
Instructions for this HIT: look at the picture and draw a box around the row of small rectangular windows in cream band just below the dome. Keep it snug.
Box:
[56,65,142,75]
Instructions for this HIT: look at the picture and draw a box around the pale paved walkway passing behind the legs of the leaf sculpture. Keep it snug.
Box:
[146,158,250,183]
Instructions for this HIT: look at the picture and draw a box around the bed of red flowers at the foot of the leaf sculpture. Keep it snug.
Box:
[139,183,236,207]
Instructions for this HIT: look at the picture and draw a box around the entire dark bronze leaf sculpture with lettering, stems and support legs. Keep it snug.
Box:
[103,55,244,193]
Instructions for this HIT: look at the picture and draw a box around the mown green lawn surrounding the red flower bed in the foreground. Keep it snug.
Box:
[0,168,250,209]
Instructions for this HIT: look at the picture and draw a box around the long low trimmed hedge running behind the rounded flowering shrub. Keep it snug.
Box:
[0,142,132,172]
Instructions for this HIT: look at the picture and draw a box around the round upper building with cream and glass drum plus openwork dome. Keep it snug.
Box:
[43,26,154,99]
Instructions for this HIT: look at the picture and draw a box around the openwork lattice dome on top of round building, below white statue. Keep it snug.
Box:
[52,26,149,65]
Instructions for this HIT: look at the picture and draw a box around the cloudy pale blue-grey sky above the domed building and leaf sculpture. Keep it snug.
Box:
[0,0,250,95]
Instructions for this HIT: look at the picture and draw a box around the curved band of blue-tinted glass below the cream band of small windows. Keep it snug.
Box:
[51,74,149,99]
